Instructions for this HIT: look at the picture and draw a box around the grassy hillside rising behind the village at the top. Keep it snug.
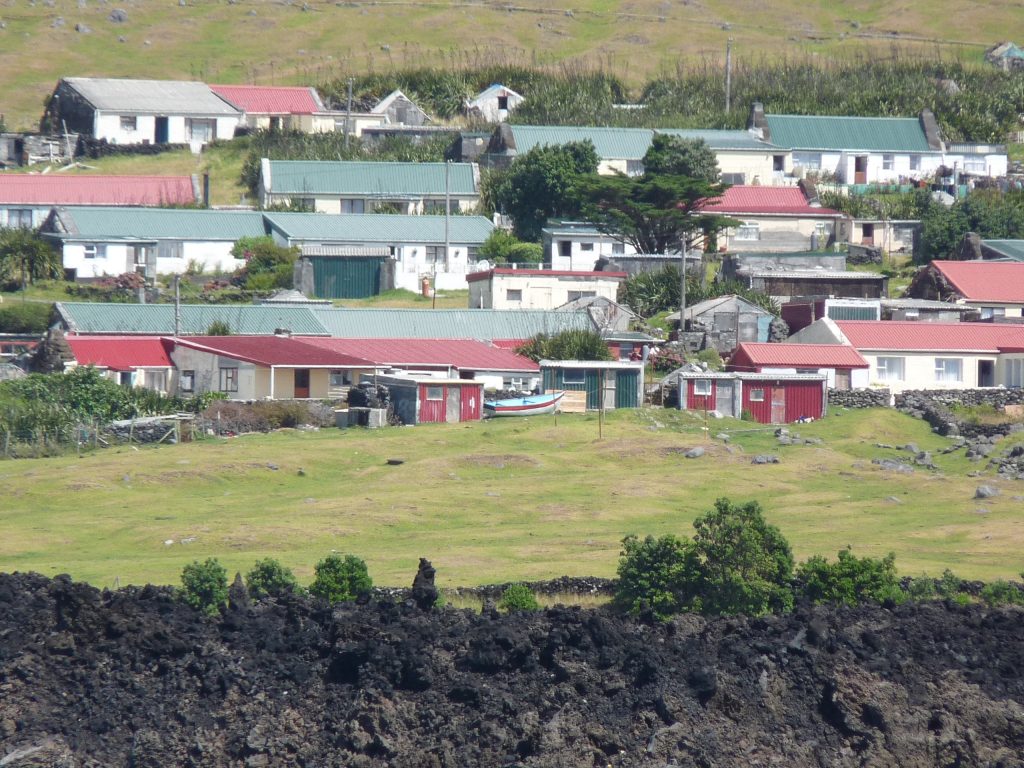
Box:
[0,0,1021,129]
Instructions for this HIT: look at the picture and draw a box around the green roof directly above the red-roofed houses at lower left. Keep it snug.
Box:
[56,301,328,336]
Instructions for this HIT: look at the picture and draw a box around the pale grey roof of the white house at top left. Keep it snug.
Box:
[63,78,239,116]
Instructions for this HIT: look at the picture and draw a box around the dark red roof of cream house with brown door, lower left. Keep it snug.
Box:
[174,336,375,368]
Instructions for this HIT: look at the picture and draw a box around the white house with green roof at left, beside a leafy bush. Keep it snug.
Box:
[40,206,266,280]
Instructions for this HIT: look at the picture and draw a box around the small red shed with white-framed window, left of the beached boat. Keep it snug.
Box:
[362,375,483,424]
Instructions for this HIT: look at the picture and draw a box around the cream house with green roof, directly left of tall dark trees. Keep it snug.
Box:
[258,158,480,215]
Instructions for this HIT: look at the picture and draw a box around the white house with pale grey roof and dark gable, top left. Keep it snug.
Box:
[44,78,242,152]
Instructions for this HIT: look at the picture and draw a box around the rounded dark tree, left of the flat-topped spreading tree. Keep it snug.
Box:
[487,141,598,241]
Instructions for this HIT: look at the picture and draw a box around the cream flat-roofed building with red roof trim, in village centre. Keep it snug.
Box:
[466,267,627,309]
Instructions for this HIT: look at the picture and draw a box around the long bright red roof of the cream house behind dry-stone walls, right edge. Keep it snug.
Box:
[836,321,1024,353]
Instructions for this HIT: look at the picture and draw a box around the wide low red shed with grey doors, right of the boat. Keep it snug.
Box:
[675,372,827,424]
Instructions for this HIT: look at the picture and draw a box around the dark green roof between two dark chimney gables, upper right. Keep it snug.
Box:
[766,115,935,153]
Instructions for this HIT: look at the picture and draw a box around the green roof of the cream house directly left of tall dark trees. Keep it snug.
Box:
[264,160,477,199]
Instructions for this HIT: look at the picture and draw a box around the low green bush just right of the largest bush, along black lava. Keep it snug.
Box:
[797,549,905,605]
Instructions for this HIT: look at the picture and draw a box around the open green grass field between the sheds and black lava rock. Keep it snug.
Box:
[0,410,1024,587]
